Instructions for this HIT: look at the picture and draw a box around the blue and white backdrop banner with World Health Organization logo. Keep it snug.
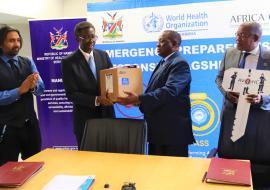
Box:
[88,0,270,157]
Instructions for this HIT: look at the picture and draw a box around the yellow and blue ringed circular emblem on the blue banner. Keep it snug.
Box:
[190,93,220,136]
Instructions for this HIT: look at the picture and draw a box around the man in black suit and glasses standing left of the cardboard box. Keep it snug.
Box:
[62,21,115,148]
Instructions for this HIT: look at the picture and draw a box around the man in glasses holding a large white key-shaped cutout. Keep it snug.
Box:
[216,22,270,188]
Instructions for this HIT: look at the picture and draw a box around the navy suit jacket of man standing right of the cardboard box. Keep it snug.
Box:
[139,52,194,145]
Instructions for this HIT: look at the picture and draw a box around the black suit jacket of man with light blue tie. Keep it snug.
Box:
[61,49,114,137]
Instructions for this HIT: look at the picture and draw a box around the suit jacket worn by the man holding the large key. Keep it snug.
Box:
[216,47,270,163]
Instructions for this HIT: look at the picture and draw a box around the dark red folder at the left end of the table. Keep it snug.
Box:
[0,162,44,187]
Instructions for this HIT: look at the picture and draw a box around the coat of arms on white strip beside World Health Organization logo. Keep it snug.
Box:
[102,13,123,38]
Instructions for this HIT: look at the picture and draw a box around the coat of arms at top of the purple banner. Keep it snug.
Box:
[50,27,68,50]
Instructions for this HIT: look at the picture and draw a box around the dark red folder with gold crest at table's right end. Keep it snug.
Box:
[205,158,251,186]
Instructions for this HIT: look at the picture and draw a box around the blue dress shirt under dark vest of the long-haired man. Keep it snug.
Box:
[0,55,45,105]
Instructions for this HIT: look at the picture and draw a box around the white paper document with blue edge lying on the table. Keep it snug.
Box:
[42,175,95,190]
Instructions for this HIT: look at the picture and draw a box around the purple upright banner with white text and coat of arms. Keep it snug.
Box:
[29,18,86,149]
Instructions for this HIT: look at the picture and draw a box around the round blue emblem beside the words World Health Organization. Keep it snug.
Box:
[143,13,164,32]
